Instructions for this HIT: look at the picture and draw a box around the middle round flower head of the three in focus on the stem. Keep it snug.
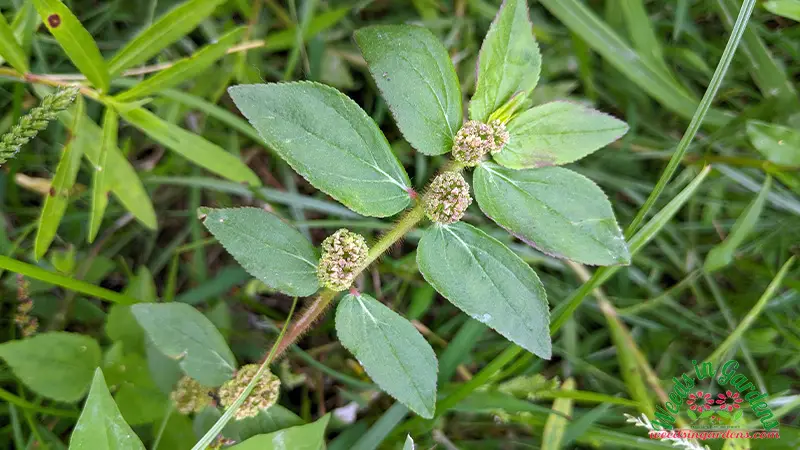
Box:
[423,172,472,224]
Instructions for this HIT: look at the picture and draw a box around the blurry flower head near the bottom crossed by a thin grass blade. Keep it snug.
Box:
[218,364,281,420]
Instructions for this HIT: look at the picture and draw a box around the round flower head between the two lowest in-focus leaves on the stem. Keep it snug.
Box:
[317,228,369,291]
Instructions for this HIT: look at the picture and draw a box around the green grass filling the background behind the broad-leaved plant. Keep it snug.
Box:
[0,0,800,450]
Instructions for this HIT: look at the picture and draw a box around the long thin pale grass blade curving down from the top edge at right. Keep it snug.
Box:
[625,0,756,238]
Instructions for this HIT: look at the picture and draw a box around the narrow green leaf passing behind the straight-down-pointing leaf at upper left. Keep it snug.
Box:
[61,111,158,230]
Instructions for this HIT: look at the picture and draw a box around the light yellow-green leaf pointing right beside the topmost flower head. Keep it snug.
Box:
[494,102,628,169]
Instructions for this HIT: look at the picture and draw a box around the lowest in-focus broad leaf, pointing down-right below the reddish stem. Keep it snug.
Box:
[336,294,438,419]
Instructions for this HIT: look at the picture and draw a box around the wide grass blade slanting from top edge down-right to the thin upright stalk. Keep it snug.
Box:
[541,0,729,126]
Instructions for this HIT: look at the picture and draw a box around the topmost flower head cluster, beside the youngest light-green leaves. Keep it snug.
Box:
[453,120,508,167]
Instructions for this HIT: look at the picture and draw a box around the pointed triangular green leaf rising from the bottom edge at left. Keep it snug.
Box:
[69,368,144,450]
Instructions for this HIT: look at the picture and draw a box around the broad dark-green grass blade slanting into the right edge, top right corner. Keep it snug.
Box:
[714,0,798,103]
